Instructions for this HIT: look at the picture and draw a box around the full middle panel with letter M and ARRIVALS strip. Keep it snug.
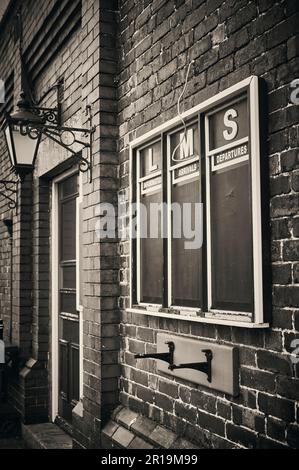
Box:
[168,122,202,307]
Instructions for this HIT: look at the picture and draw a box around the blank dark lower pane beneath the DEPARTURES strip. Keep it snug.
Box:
[211,162,253,312]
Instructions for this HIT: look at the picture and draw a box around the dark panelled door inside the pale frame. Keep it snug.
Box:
[58,175,79,423]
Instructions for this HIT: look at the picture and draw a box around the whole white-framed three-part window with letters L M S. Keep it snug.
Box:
[131,77,267,326]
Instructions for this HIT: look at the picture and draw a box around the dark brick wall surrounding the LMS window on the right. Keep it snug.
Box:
[119,0,299,448]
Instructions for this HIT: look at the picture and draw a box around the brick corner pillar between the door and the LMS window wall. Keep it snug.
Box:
[74,0,119,448]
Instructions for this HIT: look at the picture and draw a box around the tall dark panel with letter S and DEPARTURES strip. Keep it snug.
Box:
[205,93,254,313]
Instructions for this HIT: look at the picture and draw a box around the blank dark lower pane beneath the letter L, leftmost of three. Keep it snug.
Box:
[140,191,163,303]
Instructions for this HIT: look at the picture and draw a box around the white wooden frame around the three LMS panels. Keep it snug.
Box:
[127,76,269,328]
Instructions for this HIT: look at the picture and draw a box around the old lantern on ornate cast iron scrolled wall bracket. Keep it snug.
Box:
[2,80,95,181]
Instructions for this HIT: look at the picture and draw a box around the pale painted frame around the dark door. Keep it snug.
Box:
[51,168,83,422]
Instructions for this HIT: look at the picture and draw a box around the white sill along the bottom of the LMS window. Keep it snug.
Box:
[126,307,270,329]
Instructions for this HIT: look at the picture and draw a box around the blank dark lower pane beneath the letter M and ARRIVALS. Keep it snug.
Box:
[172,180,202,307]
